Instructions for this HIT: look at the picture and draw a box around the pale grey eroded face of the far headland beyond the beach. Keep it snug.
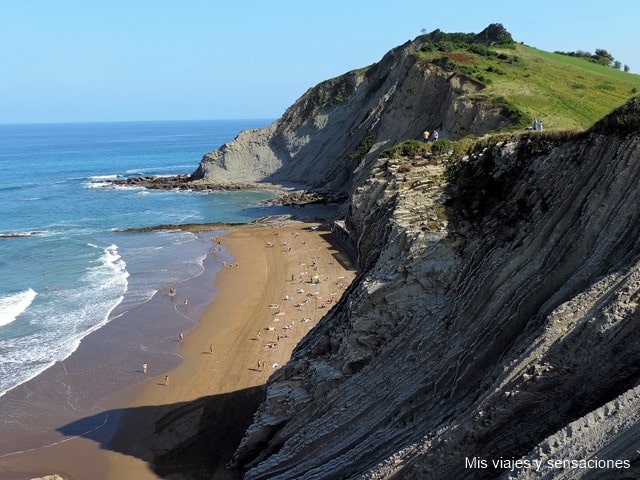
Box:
[193,36,516,196]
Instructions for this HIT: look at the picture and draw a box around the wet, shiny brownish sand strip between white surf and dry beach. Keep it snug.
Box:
[0,230,229,480]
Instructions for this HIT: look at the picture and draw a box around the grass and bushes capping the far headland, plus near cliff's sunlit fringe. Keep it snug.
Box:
[382,24,640,167]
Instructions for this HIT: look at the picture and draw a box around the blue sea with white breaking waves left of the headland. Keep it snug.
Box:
[0,120,312,396]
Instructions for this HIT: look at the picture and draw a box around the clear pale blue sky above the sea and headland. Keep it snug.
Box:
[0,0,640,123]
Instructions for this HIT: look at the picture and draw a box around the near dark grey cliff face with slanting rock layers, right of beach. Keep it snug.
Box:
[234,100,640,479]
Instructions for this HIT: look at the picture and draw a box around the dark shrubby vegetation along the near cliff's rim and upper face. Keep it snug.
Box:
[383,96,640,223]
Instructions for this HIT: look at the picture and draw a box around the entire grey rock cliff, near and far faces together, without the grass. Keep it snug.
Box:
[146,26,640,480]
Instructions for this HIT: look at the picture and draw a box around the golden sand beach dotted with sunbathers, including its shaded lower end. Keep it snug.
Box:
[0,222,355,480]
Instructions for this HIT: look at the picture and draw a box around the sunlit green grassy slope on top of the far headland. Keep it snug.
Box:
[417,44,640,130]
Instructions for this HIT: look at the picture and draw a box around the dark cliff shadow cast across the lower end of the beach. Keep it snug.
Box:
[57,387,265,480]
